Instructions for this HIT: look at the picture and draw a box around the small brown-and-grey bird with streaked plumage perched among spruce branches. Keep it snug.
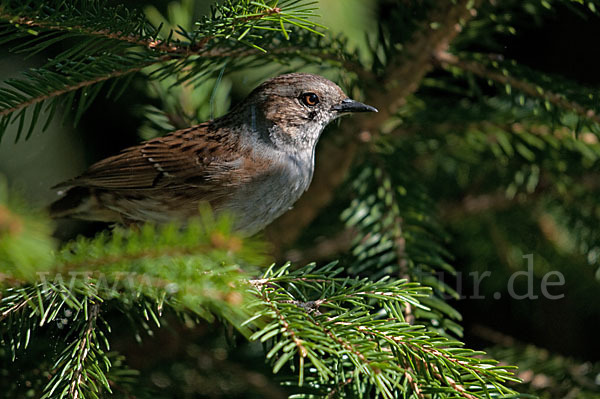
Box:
[49,73,377,235]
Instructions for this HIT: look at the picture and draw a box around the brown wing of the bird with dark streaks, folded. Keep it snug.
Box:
[56,124,242,190]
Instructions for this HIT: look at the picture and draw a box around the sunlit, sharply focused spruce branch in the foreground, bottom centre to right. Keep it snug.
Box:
[249,264,514,398]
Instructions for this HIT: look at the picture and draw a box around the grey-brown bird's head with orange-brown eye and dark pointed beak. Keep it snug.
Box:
[233,73,377,151]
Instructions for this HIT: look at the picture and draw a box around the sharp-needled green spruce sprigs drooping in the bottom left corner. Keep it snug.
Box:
[0,282,116,398]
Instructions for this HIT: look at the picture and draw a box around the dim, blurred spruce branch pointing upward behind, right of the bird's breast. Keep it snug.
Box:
[341,159,462,336]
